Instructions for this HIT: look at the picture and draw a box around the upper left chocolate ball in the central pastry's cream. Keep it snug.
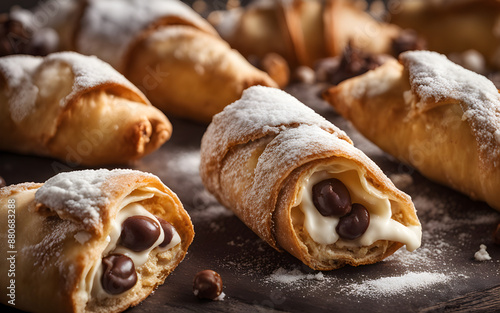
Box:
[312,178,351,216]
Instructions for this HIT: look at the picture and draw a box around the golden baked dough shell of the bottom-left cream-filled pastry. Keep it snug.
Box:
[0,172,194,312]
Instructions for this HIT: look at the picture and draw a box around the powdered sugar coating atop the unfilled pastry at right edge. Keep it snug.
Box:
[400,51,500,161]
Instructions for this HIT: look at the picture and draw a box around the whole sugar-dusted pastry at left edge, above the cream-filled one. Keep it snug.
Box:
[0,52,172,165]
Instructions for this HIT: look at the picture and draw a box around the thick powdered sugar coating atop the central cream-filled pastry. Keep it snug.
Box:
[201,86,350,191]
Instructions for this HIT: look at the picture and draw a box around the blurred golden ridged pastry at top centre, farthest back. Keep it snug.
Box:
[209,0,408,67]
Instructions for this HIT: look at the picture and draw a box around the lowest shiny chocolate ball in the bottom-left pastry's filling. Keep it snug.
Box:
[101,254,137,295]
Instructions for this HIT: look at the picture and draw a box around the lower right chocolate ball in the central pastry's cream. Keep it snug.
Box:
[336,203,370,240]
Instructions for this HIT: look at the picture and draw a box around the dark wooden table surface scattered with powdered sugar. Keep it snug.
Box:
[0,85,500,313]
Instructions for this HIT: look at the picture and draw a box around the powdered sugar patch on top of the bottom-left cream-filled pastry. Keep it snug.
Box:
[35,169,141,229]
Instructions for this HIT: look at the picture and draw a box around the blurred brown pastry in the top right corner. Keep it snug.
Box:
[391,0,500,69]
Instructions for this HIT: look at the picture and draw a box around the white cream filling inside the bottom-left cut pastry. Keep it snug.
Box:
[81,187,181,299]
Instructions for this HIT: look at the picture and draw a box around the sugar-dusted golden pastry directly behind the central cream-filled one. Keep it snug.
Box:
[42,0,276,123]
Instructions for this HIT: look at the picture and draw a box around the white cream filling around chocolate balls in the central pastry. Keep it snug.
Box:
[292,160,422,251]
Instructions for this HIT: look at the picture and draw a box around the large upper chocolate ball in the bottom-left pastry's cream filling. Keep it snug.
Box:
[120,215,161,252]
